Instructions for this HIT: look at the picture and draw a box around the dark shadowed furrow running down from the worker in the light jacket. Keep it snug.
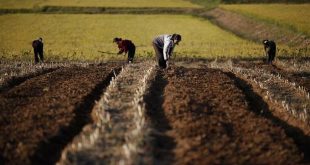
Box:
[144,70,176,164]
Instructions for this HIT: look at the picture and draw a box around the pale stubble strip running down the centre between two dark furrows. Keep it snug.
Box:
[58,62,155,164]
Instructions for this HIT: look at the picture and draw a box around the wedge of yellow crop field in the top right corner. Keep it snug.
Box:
[220,4,310,36]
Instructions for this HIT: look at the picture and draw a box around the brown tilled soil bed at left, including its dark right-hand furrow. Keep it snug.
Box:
[0,64,117,164]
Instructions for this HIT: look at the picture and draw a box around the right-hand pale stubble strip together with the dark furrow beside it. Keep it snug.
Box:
[210,61,310,162]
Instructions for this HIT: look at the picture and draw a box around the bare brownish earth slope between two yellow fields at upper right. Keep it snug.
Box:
[201,8,310,48]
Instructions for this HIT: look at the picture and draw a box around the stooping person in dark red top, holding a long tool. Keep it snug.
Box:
[113,37,136,63]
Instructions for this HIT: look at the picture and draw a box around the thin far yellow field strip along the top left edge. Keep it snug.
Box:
[0,0,200,8]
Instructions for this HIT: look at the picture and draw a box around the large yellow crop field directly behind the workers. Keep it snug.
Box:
[0,14,280,60]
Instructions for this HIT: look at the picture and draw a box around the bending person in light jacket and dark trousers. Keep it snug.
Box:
[153,34,181,69]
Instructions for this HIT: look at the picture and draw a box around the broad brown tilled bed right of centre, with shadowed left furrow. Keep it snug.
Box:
[147,67,303,164]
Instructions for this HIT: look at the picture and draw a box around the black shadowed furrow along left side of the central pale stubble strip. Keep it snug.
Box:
[31,68,121,165]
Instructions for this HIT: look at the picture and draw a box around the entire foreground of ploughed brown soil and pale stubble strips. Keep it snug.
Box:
[0,60,310,164]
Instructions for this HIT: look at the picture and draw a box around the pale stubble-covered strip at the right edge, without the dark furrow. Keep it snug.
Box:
[210,62,310,125]
